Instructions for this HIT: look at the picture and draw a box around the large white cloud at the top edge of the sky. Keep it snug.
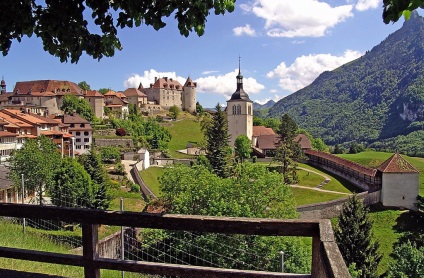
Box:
[241,0,353,38]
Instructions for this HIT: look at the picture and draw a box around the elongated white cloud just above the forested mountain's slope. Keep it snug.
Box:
[267,50,362,92]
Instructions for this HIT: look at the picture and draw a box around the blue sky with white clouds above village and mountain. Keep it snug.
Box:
[0,0,410,108]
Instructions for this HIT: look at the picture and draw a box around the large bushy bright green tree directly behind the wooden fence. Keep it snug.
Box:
[156,162,311,273]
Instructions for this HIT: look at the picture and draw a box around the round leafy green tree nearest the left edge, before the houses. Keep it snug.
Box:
[9,135,61,205]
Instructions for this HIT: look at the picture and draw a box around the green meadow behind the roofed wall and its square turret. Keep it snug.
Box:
[338,151,424,196]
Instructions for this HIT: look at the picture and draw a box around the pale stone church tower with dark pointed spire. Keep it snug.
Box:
[226,59,253,147]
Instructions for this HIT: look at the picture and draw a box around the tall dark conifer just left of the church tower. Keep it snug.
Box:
[205,103,231,178]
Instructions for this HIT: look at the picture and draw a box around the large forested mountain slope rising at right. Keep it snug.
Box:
[268,12,424,148]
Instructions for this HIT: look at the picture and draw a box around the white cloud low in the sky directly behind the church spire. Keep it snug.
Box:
[195,69,265,98]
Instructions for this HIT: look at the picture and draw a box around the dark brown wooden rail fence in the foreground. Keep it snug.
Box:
[0,203,350,278]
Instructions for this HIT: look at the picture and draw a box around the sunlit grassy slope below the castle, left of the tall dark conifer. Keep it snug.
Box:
[163,116,203,158]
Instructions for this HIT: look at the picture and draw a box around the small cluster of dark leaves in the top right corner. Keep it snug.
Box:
[383,0,424,24]
